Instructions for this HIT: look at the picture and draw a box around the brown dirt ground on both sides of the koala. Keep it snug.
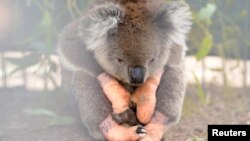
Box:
[0,85,250,141]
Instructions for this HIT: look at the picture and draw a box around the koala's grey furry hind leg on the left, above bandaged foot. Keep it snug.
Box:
[72,71,112,141]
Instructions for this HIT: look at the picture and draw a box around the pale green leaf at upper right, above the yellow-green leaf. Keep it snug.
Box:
[198,3,216,21]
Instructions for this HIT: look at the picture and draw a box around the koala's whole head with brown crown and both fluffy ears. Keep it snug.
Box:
[79,1,191,85]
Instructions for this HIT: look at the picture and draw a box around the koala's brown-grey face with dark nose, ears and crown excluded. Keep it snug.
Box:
[95,23,169,85]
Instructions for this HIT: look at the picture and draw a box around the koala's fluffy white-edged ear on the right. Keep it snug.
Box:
[153,1,192,45]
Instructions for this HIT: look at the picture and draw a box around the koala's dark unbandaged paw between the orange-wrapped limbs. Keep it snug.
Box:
[111,109,139,126]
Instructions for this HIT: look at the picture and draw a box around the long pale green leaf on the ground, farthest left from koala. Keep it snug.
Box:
[23,108,57,117]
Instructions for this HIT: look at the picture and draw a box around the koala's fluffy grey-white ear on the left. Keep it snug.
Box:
[79,3,124,51]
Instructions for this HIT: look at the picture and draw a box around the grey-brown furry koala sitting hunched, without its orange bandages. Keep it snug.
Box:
[58,0,192,140]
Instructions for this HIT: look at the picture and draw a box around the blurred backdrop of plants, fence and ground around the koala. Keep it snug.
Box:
[0,0,250,141]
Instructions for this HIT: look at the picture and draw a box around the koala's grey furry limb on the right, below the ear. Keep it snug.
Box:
[156,45,186,125]
